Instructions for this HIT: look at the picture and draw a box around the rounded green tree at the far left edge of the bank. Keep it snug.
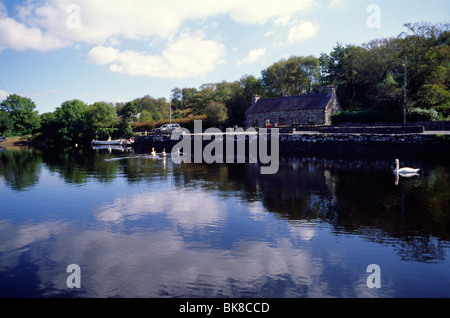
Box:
[0,94,40,135]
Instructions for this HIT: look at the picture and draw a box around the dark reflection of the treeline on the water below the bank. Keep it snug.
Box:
[0,149,450,262]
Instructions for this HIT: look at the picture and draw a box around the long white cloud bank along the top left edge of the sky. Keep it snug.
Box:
[0,0,313,50]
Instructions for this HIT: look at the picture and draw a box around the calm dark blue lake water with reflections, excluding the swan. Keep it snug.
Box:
[0,149,450,298]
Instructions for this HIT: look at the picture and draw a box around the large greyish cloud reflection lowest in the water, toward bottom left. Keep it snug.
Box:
[0,219,327,297]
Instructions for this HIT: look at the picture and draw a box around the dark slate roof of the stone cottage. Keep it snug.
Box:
[246,93,332,114]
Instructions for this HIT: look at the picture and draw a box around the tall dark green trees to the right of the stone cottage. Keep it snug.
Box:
[320,23,450,120]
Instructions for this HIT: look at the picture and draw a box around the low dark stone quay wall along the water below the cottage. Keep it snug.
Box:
[133,131,450,158]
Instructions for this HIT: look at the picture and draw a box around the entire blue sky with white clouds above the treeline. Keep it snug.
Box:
[0,0,450,114]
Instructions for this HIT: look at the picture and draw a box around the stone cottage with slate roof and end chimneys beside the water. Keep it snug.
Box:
[245,86,341,127]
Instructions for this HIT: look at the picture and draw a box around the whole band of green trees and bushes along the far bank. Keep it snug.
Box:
[0,23,450,142]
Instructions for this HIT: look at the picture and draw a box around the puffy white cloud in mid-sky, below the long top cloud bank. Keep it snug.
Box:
[87,32,226,79]
